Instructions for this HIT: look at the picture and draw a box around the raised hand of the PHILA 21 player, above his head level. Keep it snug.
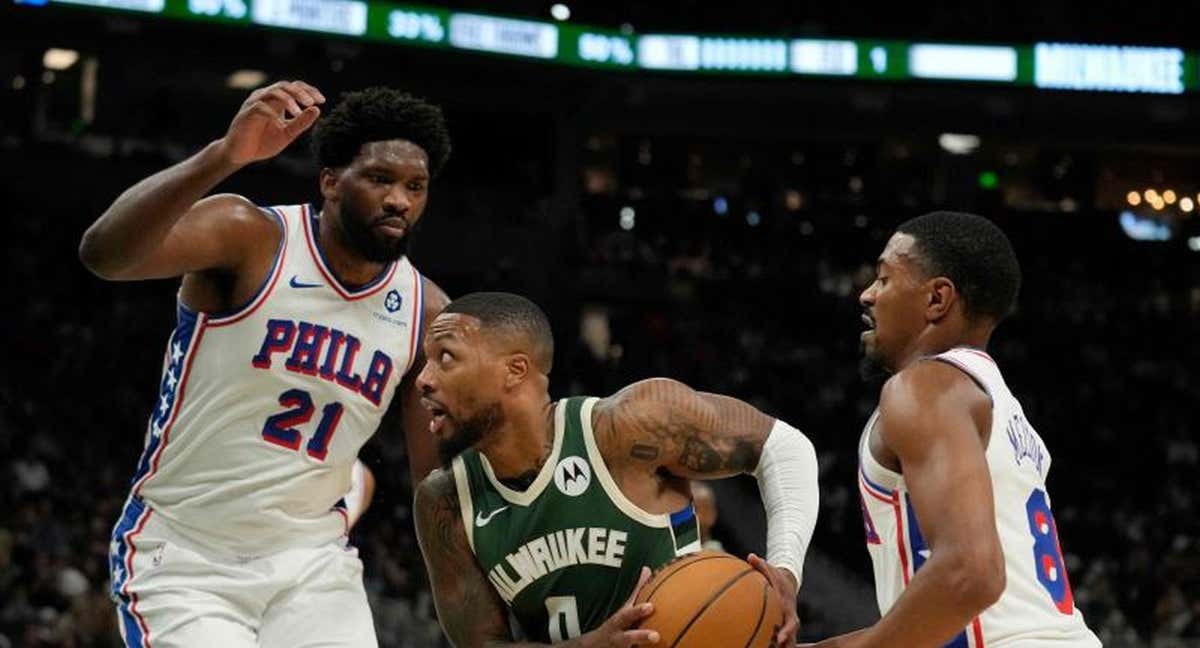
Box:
[221,80,325,164]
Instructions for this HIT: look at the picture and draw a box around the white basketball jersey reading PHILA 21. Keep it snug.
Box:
[124,205,422,558]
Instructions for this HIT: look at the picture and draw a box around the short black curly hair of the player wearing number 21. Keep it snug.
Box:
[312,88,450,176]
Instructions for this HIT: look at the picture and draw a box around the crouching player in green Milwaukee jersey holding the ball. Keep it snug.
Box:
[415,293,817,648]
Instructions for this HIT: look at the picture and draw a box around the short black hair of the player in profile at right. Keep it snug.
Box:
[896,211,1021,323]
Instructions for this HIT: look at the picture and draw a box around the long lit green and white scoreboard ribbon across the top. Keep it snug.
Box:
[17,0,1200,95]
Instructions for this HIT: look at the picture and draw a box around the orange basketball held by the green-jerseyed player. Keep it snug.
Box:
[636,551,784,648]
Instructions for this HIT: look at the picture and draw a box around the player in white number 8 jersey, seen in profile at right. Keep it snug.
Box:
[817,211,1100,648]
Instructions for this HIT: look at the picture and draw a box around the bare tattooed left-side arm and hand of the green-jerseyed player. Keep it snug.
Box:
[415,470,659,648]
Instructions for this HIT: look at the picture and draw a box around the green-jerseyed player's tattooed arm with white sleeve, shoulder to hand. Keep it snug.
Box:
[593,378,820,646]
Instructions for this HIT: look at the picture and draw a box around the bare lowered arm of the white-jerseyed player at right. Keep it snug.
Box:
[817,361,1006,648]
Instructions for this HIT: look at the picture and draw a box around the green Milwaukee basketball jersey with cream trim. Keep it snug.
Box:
[454,398,700,642]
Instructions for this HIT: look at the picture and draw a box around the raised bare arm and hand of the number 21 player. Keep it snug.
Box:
[79,82,325,280]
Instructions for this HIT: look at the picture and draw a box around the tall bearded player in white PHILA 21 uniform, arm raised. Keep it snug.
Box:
[79,82,450,648]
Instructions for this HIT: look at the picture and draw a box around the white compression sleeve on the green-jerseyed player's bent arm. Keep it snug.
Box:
[754,420,821,586]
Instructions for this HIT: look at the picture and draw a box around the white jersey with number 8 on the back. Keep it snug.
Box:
[858,348,1100,648]
